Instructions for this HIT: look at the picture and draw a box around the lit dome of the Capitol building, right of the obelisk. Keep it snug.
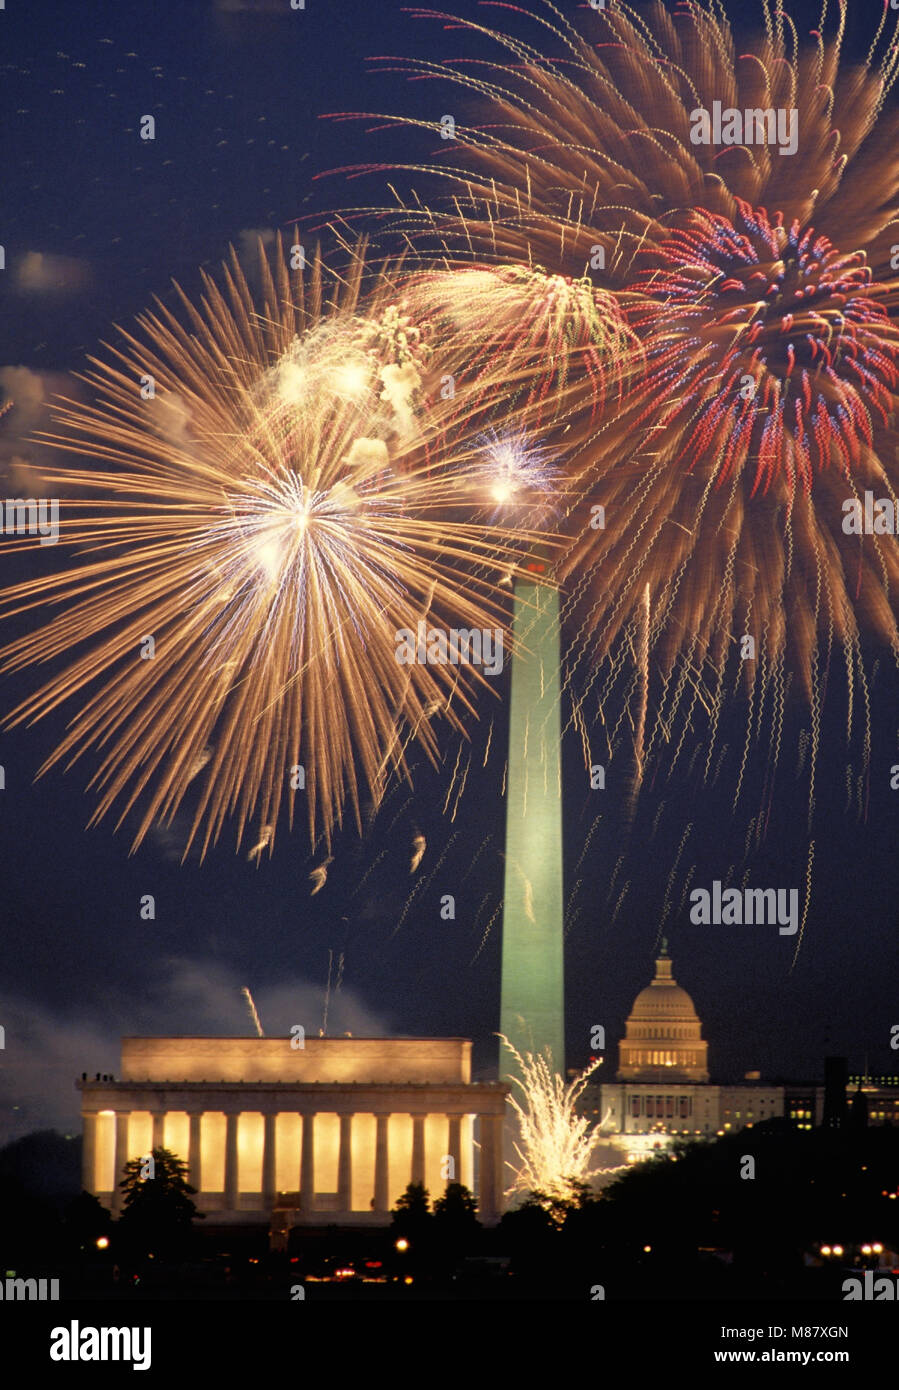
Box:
[618,941,709,1081]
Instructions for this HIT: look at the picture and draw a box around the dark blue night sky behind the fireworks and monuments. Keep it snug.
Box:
[0,0,899,1141]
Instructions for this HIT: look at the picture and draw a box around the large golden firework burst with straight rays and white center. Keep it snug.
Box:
[1,239,547,856]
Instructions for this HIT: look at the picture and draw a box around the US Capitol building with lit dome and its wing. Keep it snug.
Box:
[582,941,824,1162]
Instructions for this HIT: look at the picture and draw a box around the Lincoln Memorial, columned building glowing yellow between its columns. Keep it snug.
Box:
[78,1037,507,1227]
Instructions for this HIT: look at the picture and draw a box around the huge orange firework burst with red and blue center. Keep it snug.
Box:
[350,0,899,806]
